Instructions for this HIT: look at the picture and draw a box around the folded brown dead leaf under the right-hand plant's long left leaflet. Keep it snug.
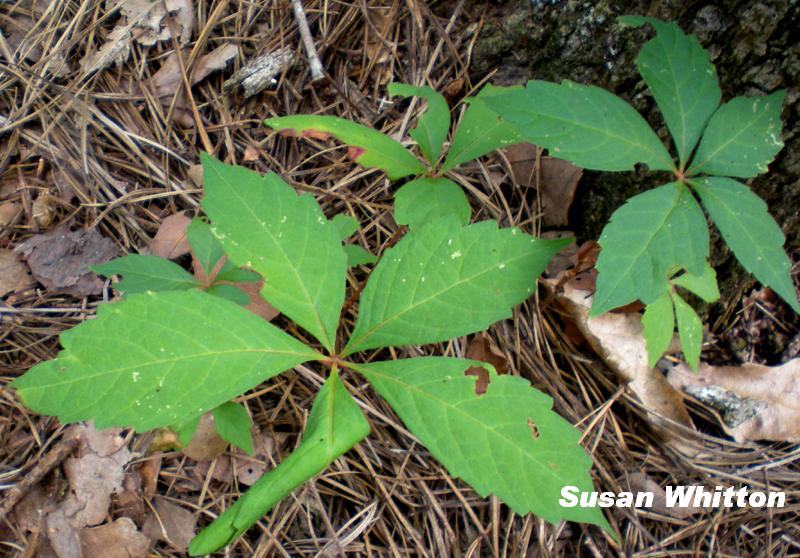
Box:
[503,147,583,227]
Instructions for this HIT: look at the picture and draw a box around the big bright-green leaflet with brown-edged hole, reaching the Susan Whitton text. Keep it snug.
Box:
[354,357,612,533]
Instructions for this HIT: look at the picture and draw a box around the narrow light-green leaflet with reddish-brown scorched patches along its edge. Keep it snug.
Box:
[264,115,427,180]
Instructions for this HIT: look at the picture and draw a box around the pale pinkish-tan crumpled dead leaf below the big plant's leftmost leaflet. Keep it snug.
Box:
[59,424,133,528]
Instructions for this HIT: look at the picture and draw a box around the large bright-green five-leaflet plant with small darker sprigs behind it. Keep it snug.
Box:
[11,154,613,555]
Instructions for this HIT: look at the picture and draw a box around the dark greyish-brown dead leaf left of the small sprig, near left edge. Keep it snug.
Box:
[15,227,118,296]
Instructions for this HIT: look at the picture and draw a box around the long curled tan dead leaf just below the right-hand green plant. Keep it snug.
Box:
[543,272,694,450]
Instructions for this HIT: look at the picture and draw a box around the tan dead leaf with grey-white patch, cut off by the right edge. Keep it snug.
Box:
[667,359,800,443]
